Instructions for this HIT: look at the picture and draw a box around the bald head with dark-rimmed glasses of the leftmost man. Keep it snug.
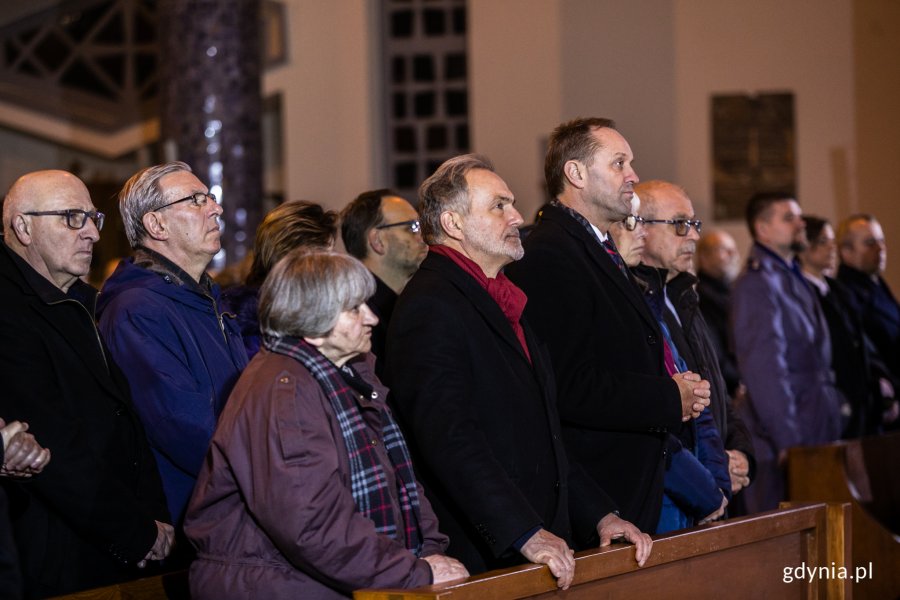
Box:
[3,170,100,291]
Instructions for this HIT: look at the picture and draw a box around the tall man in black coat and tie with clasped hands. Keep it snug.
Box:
[508,119,709,532]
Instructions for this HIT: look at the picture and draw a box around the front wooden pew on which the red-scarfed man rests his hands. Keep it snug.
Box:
[353,503,853,600]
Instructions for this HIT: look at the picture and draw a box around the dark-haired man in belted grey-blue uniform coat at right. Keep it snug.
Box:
[732,194,844,512]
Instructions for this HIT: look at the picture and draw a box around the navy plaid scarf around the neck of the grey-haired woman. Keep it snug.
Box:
[263,336,422,556]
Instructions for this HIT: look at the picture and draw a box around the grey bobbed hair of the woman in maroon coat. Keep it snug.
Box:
[259,248,375,337]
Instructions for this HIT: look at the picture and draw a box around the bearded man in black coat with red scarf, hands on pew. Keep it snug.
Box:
[387,155,651,588]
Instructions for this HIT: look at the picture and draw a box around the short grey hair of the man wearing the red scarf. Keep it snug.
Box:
[419,154,494,245]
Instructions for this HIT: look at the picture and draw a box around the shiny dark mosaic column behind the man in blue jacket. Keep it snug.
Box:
[159,0,263,268]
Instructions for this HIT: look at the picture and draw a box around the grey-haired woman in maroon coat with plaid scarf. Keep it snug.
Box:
[185,251,468,600]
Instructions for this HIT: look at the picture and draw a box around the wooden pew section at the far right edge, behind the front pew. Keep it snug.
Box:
[788,434,900,600]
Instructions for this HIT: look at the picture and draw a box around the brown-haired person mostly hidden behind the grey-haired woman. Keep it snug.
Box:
[222,200,337,359]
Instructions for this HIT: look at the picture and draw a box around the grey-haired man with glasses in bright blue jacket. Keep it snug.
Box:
[97,162,247,544]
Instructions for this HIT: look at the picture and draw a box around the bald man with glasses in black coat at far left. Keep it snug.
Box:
[0,171,173,598]
